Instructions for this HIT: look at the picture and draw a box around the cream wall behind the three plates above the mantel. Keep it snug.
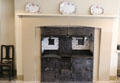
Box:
[15,0,119,14]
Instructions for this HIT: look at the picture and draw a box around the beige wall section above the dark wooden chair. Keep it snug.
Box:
[0,0,15,45]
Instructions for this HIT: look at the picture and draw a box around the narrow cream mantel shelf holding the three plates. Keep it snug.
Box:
[16,13,119,19]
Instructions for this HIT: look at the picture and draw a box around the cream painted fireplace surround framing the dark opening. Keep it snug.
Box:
[16,14,119,81]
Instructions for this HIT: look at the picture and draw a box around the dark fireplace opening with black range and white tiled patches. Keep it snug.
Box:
[41,26,94,83]
